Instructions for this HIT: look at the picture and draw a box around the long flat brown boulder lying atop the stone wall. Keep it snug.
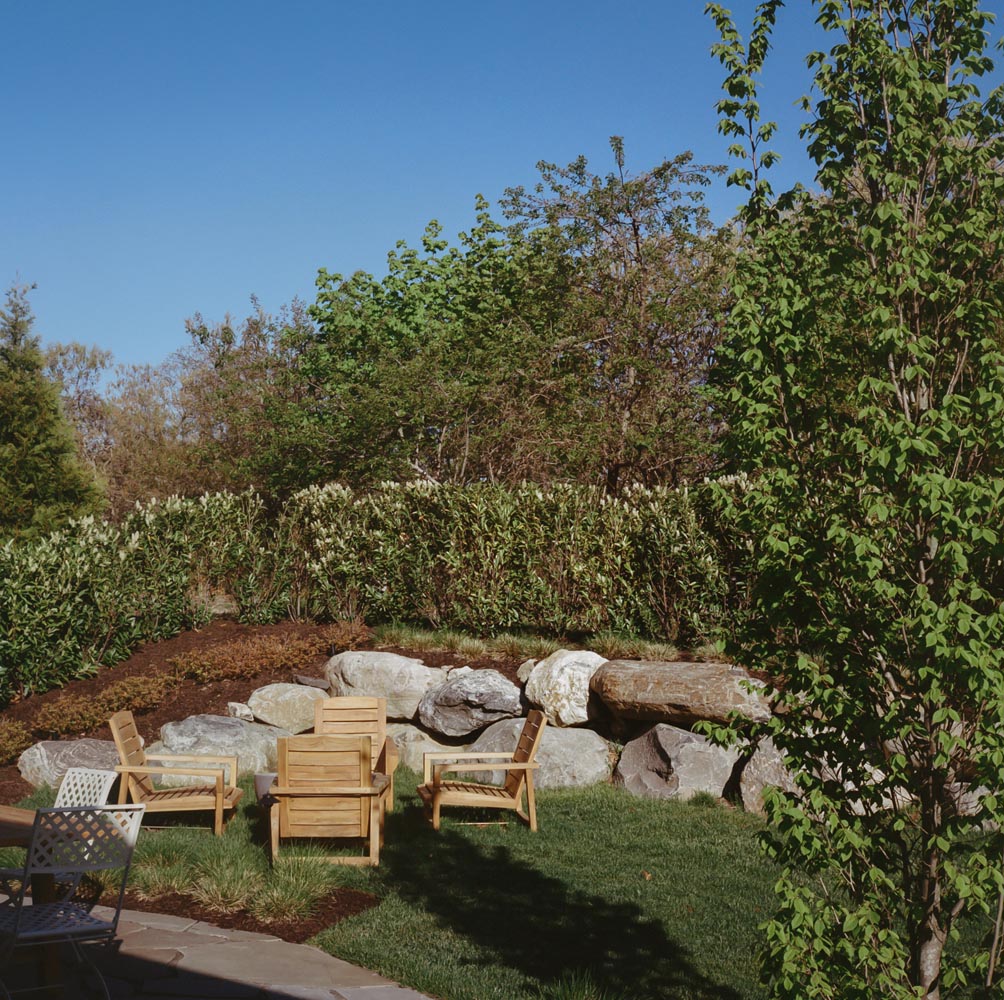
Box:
[589,660,770,727]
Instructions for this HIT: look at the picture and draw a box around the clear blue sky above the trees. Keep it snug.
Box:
[0,0,1004,363]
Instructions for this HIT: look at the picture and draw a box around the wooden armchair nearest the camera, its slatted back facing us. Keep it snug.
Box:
[268,733,390,864]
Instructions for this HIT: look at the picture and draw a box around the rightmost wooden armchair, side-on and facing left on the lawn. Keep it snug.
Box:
[419,710,547,830]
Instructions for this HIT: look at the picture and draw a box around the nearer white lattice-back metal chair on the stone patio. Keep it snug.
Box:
[0,805,146,1000]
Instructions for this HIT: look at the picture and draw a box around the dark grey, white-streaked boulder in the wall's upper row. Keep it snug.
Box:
[419,667,522,736]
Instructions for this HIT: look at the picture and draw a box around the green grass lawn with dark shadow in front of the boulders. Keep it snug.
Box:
[0,770,775,1000]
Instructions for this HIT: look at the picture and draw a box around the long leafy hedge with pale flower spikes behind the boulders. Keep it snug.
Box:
[0,484,736,704]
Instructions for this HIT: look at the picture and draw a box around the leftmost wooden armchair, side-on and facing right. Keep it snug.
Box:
[108,711,244,836]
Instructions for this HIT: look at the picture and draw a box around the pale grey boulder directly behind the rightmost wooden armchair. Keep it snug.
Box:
[468,719,612,788]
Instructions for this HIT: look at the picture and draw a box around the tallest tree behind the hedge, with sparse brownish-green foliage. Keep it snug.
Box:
[502,136,735,493]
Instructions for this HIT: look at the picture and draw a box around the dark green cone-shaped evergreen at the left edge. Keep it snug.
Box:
[0,285,101,539]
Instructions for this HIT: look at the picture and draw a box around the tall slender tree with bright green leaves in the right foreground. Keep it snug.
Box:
[708,0,1004,1000]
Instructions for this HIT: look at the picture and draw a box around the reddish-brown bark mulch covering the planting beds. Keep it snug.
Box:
[0,618,519,942]
